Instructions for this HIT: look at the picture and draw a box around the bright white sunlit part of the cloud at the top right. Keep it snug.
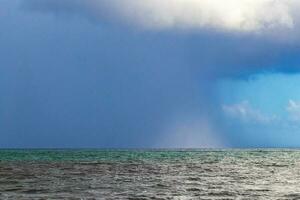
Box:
[103,0,296,31]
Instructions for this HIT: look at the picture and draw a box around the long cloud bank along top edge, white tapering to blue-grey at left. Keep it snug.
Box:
[26,0,300,33]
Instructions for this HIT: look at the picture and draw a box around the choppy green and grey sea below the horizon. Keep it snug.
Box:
[0,149,300,200]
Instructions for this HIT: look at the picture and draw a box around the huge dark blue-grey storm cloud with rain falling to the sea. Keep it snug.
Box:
[0,0,299,147]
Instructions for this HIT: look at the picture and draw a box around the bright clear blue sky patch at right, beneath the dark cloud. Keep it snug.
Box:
[219,73,300,147]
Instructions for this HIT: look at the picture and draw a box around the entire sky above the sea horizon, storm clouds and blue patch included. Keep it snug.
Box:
[0,0,300,148]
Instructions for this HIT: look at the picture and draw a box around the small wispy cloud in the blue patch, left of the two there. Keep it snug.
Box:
[222,101,276,123]
